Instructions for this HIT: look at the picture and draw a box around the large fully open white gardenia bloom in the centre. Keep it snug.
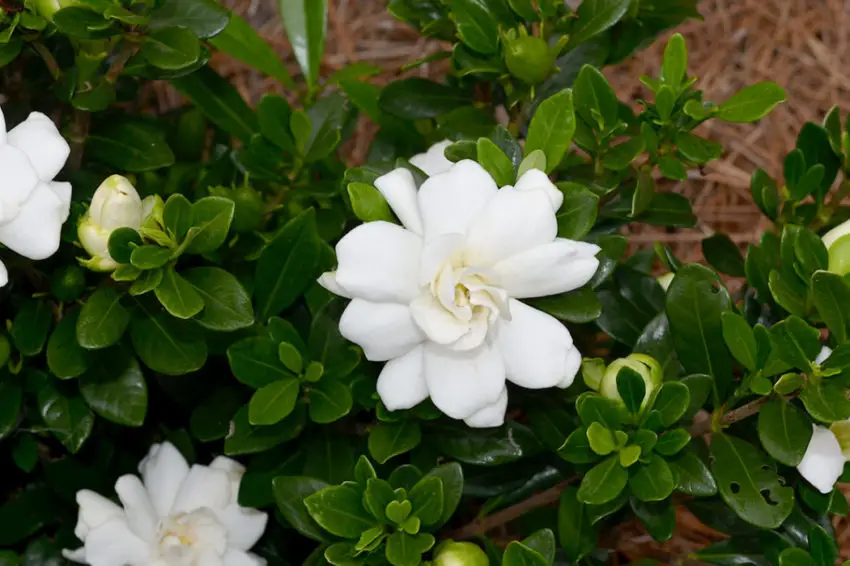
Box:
[319,160,599,427]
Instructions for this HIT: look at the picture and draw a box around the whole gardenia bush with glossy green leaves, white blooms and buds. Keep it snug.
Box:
[0,0,850,566]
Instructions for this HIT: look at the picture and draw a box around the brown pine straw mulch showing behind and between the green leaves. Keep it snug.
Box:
[162,0,850,564]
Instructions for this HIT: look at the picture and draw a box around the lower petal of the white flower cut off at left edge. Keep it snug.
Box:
[0,183,66,259]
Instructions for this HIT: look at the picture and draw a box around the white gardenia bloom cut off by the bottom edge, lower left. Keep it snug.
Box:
[62,442,268,566]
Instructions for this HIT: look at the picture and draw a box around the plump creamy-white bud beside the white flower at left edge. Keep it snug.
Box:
[77,175,143,271]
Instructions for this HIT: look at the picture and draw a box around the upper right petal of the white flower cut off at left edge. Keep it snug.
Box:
[7,112,71,181]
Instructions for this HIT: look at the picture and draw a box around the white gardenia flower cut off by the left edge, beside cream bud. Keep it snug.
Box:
[0,106,71,287]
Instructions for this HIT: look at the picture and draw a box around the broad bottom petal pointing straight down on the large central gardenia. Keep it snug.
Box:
[424,344,505,419]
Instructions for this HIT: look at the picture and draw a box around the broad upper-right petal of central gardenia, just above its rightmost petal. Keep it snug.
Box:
[466,187,558,267]
